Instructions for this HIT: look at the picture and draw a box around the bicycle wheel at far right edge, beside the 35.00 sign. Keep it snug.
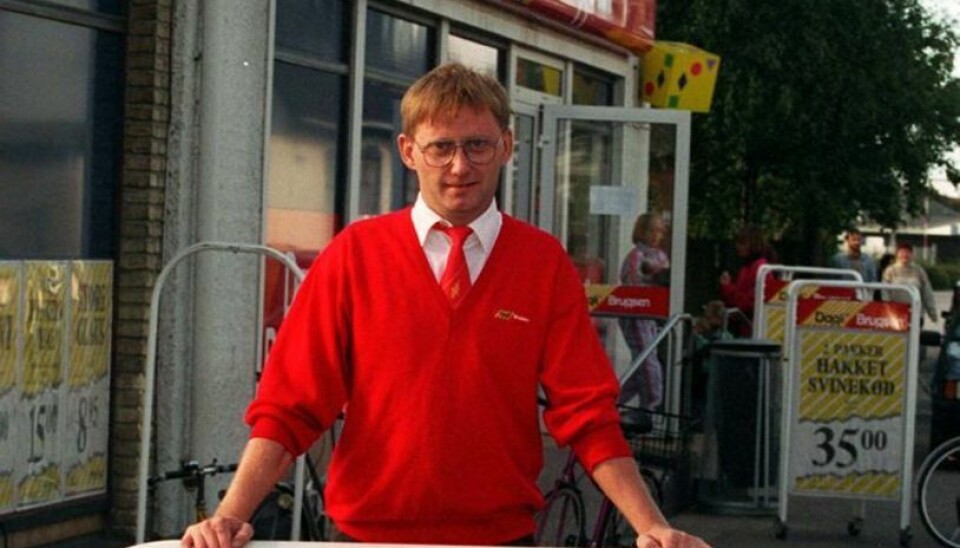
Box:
[917,438,960,548]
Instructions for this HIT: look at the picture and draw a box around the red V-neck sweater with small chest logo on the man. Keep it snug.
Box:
[247,209,630,544]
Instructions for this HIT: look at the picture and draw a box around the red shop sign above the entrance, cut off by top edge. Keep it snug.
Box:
[506,0,657,53]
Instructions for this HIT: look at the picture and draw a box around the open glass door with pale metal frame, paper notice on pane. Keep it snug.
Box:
[536,105,690,406]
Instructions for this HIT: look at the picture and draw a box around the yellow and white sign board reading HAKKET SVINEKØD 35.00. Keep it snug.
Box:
[789,299,910,499]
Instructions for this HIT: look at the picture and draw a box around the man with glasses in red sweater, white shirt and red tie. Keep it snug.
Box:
[182,64,704,548]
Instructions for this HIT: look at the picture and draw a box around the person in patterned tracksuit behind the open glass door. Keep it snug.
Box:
[618,213,670,410]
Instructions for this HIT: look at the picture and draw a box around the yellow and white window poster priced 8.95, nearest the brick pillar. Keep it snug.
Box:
[61,261,113,496]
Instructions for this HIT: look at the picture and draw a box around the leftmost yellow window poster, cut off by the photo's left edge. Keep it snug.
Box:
[0,261,22,512]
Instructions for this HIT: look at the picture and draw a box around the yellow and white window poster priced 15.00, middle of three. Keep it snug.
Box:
[14,261,67,507]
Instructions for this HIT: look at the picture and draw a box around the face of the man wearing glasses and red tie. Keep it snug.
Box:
[397,107,513,225]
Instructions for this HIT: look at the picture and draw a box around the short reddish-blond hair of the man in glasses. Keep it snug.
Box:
[400,63,510,136]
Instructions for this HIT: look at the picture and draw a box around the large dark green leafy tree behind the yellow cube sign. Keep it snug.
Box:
[657,0,960,264]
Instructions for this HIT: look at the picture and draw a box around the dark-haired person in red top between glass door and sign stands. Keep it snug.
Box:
[720,224,772,337]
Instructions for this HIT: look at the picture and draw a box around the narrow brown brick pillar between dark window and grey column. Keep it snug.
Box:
[109,0,173,535]
